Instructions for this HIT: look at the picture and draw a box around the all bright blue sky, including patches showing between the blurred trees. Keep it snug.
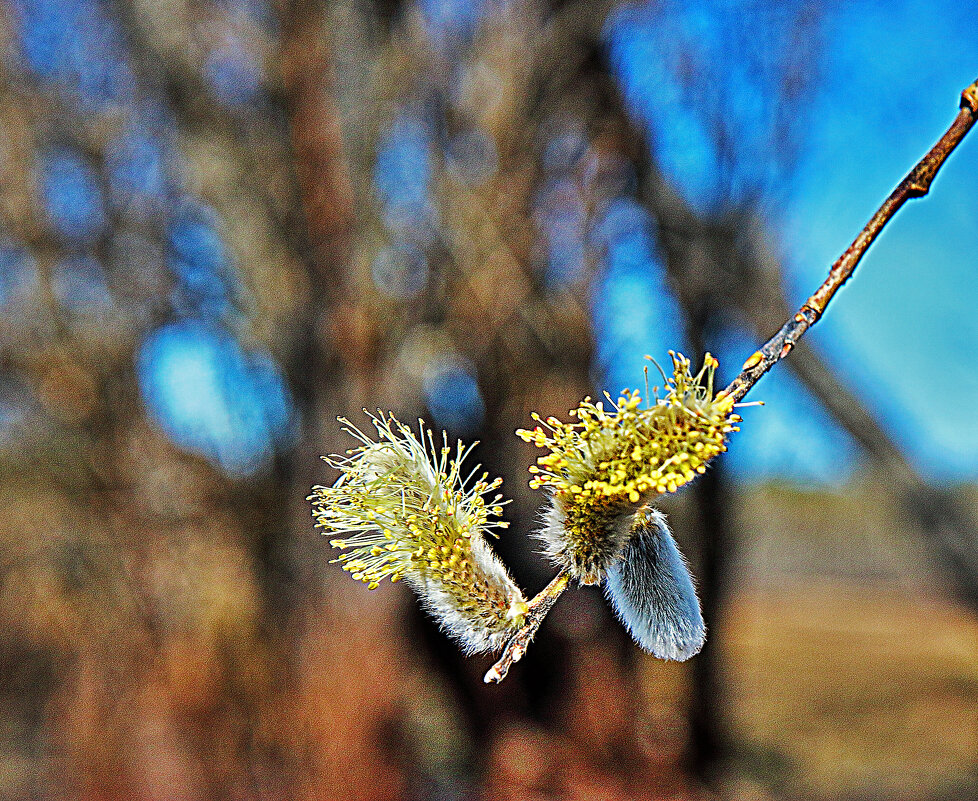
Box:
[0,0,978,483]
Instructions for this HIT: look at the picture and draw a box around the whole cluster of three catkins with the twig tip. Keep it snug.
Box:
[309,352,740,664]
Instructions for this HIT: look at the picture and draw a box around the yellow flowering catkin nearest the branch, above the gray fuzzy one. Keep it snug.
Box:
[517,351,740,584]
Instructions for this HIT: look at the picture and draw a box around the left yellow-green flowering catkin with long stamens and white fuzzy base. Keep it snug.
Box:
[309,415,527,653]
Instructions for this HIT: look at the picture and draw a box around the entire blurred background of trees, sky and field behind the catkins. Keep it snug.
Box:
[0,0,978,801]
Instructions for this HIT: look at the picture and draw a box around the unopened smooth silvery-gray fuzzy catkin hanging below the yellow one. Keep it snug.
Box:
[605,509,706,661]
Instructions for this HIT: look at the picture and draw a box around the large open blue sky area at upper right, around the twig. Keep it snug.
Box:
[780,2,978,479]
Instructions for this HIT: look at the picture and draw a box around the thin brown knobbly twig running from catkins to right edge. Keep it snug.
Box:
[725,81,978,401]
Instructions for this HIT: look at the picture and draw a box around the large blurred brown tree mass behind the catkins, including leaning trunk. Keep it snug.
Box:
[0,0,978,799]
